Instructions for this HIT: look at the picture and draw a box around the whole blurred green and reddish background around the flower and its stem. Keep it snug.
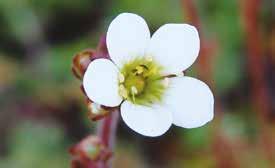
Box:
[0,0,275,168]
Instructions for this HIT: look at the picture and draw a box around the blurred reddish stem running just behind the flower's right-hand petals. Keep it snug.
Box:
[181,0,238,167]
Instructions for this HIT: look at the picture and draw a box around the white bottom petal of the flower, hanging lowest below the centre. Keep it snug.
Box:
[121,101,172,137]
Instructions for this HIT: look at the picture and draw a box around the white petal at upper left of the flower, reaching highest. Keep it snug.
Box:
[107,13,150,67]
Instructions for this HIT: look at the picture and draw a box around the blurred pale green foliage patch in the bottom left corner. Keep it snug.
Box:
[0,122,69,168]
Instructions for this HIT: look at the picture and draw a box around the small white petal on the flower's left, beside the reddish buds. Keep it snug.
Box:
[83,59,122,107]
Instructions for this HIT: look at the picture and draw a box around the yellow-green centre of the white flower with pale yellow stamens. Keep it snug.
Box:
[119,57,165,105]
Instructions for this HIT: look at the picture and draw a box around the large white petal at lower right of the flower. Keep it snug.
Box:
[166,77,214,128]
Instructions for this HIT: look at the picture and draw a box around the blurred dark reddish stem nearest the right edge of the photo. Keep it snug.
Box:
[241,0,274,160]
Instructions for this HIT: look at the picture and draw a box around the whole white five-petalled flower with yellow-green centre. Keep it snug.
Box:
[83,13,214,137]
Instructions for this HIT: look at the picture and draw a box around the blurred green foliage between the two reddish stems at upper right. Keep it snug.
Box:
[198,0,245,93]
